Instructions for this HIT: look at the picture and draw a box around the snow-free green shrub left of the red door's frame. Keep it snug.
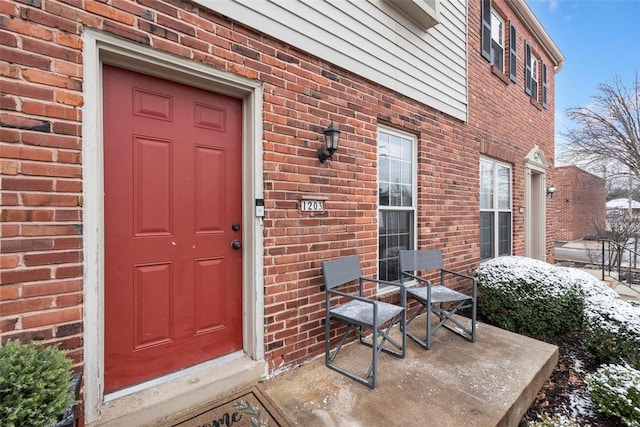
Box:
[0,340,76,427]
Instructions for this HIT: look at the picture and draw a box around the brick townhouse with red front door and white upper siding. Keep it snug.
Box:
[0,0,564,425]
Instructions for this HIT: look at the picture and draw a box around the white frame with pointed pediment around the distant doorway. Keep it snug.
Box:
[524,145,549,261]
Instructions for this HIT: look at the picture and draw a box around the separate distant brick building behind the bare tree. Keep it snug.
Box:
[553,165,607,241]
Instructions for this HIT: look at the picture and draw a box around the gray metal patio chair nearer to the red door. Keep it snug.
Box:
[322,255,406,388]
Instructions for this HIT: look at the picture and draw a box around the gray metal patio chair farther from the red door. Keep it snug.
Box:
[400,249,478,350]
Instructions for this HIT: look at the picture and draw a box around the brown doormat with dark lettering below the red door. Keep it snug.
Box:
[169,387,290,427]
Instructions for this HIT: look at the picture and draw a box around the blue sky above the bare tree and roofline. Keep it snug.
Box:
[527,0,640,163]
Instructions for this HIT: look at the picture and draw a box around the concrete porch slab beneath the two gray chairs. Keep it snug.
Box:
[260,322,558,427]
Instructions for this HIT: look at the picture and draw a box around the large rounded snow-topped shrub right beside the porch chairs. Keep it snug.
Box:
[476,256,584,338]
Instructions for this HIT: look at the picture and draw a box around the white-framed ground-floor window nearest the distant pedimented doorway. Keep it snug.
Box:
[480,158,512,260]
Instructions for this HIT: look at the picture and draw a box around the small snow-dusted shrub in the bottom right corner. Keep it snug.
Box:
[585,365,640,427]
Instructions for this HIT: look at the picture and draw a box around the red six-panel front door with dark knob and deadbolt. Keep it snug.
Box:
[104,65,242,392]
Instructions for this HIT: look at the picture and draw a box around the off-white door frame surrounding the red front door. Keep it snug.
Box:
[82,29,264,424]
